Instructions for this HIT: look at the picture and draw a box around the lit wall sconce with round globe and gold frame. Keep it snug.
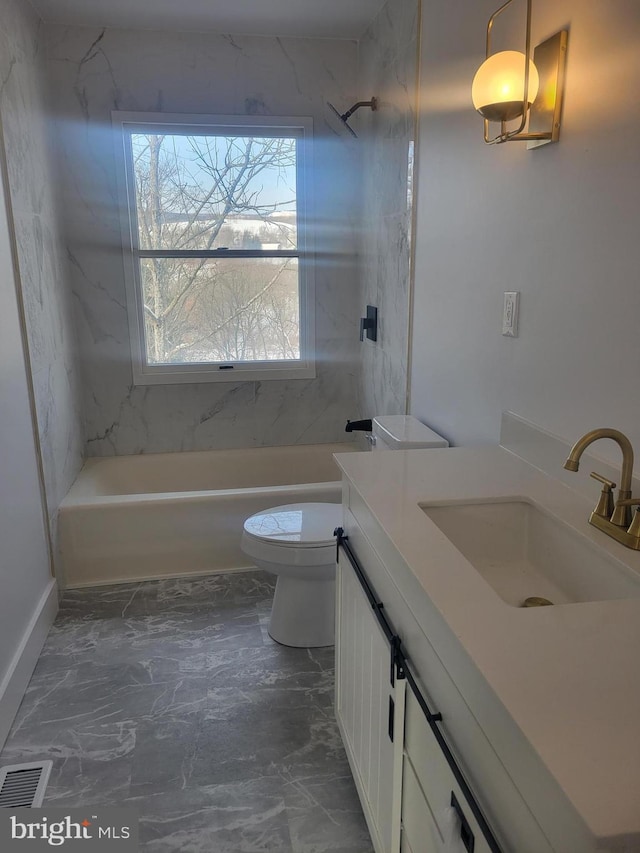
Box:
[471,0,567,148]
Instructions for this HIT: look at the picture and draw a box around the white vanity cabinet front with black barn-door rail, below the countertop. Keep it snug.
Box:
[336,496,556,853]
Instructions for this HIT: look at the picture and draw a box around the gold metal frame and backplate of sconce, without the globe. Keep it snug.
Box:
[478,0,568,148]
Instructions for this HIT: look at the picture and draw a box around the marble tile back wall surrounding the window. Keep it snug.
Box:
[48,26,359,456]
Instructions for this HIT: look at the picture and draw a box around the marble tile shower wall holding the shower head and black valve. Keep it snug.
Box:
[353,0,419,416]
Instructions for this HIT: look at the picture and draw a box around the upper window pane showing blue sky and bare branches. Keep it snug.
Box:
[131,133,297,250]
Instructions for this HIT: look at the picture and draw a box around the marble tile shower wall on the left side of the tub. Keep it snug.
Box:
[0,0,84,538]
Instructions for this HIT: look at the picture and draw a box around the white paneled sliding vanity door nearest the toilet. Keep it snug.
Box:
[336,552,405,853]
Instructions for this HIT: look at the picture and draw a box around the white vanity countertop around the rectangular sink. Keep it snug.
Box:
[336,447,640,853]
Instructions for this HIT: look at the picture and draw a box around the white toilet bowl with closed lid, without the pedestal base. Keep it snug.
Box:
[241,503,342,566]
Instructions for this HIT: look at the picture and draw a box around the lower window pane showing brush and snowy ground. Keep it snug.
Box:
[140,258,300,364]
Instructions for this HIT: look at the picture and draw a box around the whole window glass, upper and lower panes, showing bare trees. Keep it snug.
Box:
[131,131,300,365]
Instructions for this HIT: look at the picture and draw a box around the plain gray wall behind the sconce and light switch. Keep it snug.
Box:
[411,0,640,458]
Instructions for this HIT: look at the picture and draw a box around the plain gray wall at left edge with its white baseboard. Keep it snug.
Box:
[0,118,58,749]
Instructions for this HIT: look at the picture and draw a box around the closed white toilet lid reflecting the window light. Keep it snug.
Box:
[244,503,342,548]
